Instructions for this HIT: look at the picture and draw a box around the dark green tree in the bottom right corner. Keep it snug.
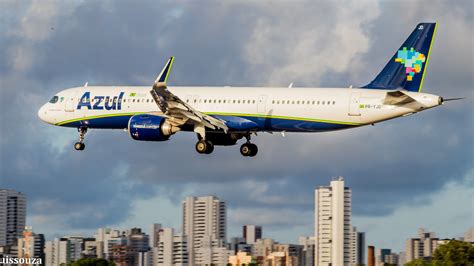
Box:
[432,240,474,266]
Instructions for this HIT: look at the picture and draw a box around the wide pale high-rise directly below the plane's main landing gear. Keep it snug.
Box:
[183,196,227,265]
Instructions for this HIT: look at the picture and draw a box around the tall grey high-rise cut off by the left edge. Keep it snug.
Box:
[0,189,26,246]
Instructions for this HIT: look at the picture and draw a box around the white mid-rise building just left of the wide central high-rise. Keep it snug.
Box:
[158,228,188,266]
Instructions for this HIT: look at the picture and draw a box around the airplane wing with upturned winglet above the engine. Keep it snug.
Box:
[150,57,229,133]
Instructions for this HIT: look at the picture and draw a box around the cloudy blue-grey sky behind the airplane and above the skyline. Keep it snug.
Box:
[0,0,474,254]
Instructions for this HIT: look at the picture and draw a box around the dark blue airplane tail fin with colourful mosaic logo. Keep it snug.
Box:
[364,23,437,92]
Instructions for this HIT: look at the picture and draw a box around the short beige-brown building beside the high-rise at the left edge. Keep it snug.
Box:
[18,227,45,263]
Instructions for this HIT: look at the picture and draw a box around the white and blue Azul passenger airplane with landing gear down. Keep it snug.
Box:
[38,23,459,157]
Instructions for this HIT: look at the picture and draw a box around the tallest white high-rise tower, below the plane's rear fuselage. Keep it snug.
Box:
[315,177,351,265]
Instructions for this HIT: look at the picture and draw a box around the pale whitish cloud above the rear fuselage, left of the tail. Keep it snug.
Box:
[244,1,380,86]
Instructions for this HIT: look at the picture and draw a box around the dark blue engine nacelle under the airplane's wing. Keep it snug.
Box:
[128,114,180,141]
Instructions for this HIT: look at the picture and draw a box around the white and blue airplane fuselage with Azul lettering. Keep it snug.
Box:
[38,86,440,132]
